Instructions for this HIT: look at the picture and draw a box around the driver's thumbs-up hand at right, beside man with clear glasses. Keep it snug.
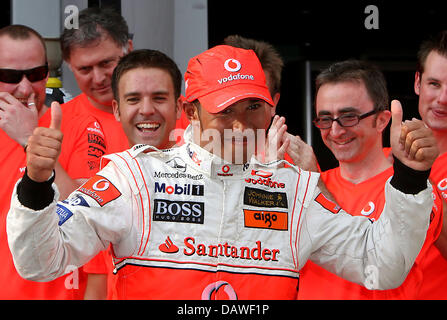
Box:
[390,100,439,171]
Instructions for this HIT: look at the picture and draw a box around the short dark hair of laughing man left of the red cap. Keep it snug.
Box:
[112,49,183,101]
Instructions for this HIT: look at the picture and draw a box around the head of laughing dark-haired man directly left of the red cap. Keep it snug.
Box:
[112,50,183,149]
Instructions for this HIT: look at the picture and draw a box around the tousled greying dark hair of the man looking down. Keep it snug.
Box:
[61,7,130,61]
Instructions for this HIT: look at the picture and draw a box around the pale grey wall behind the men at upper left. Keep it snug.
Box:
[11,0,208,96]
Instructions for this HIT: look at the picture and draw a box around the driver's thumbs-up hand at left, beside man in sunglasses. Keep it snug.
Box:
[26,102,63,182]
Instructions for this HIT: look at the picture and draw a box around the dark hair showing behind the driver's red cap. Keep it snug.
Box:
[223,35,284,96]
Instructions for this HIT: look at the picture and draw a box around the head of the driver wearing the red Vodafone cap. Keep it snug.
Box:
[185,46,275,164]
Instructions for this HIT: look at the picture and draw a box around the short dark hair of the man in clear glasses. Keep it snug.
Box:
[315,60,389,110]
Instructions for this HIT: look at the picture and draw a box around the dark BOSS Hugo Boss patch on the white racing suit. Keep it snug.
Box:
[152,199,205,224]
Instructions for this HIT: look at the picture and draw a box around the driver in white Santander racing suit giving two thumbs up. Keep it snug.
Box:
[7,46,438,299]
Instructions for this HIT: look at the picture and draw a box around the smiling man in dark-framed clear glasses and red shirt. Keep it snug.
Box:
[299,60,442,299]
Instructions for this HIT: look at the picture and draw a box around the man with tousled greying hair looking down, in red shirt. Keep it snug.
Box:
[43,8,133,298]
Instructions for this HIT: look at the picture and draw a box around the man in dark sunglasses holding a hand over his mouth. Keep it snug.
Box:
[0,25,87,300]
